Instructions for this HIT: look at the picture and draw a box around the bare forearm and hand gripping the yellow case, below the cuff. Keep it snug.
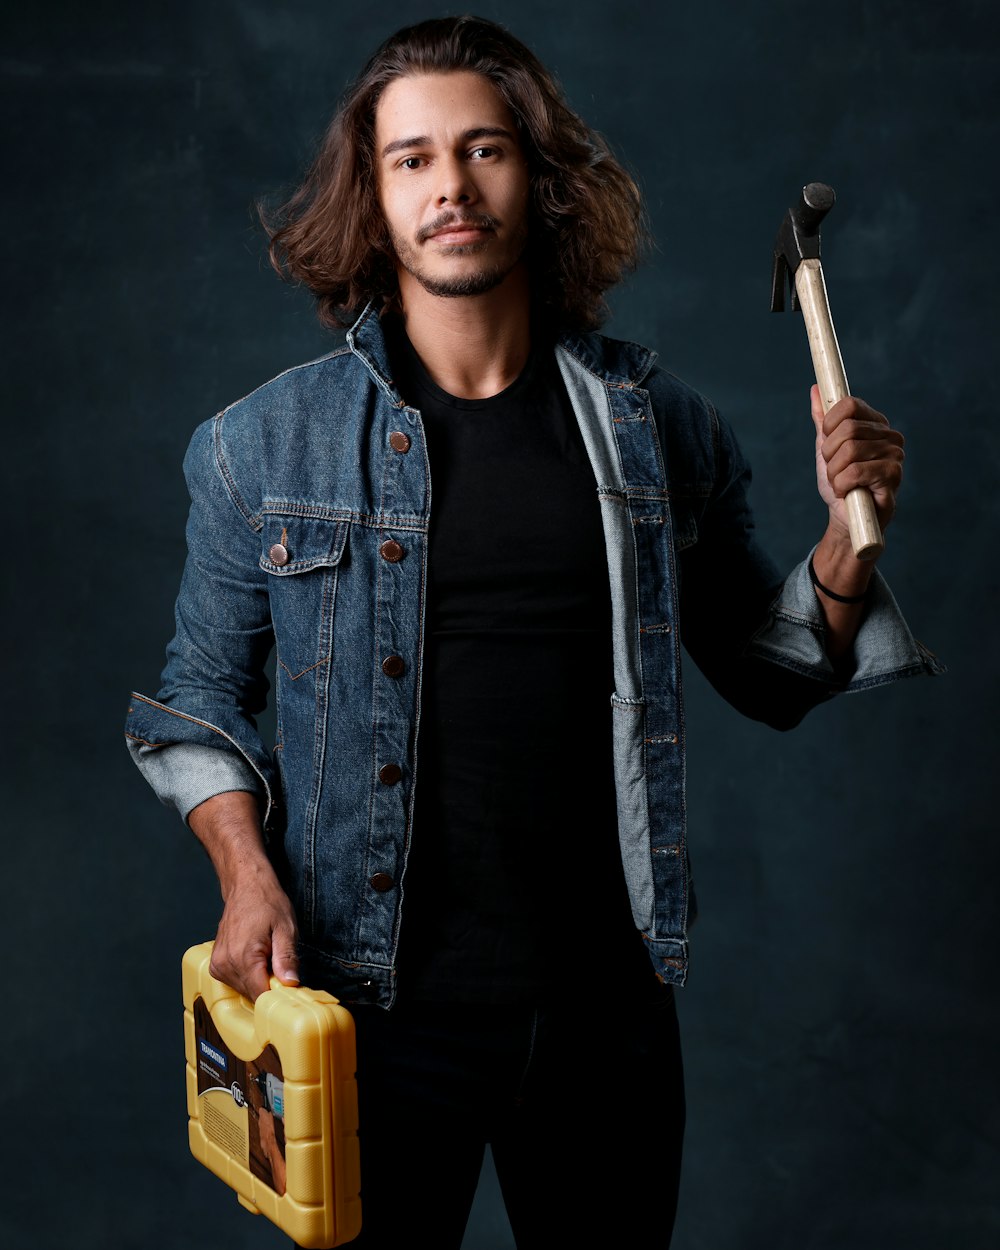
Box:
[188,790,299,1001]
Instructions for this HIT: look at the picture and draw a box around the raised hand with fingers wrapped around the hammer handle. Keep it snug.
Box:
[810,386,905,535]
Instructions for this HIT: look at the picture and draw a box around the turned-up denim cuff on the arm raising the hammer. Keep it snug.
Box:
[746,549,945,691]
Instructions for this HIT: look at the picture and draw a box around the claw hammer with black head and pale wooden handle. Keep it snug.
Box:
[771,183,885,560]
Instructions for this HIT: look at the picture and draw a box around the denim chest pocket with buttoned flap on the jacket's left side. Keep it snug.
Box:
[260,514,350,685]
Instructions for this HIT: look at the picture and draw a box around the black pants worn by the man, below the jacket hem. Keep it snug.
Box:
[354,985,684,1250]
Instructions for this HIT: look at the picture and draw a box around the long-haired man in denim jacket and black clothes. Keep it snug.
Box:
[129,18,934,1246]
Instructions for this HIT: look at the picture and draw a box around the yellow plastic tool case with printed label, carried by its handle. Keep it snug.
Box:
[183,943,361,1248]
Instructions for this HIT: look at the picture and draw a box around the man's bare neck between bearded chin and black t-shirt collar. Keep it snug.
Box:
[400,265,531,399]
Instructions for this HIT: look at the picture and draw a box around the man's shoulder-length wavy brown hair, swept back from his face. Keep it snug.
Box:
[260,18,648,330]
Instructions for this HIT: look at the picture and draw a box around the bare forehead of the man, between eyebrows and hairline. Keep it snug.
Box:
[375,71,518,153]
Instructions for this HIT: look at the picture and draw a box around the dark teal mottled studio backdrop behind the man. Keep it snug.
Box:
[0,0,1000,1250]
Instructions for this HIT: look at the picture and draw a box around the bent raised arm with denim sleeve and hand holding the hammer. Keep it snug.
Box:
[674,387,944,729]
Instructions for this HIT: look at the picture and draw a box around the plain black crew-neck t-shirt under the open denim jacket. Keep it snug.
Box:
[386,321,653,1003]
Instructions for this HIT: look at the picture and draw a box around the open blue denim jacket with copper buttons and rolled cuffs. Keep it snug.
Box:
[128,308,939,1006]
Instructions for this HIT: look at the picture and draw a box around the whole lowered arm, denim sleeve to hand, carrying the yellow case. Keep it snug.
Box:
[126,419,298,999]
